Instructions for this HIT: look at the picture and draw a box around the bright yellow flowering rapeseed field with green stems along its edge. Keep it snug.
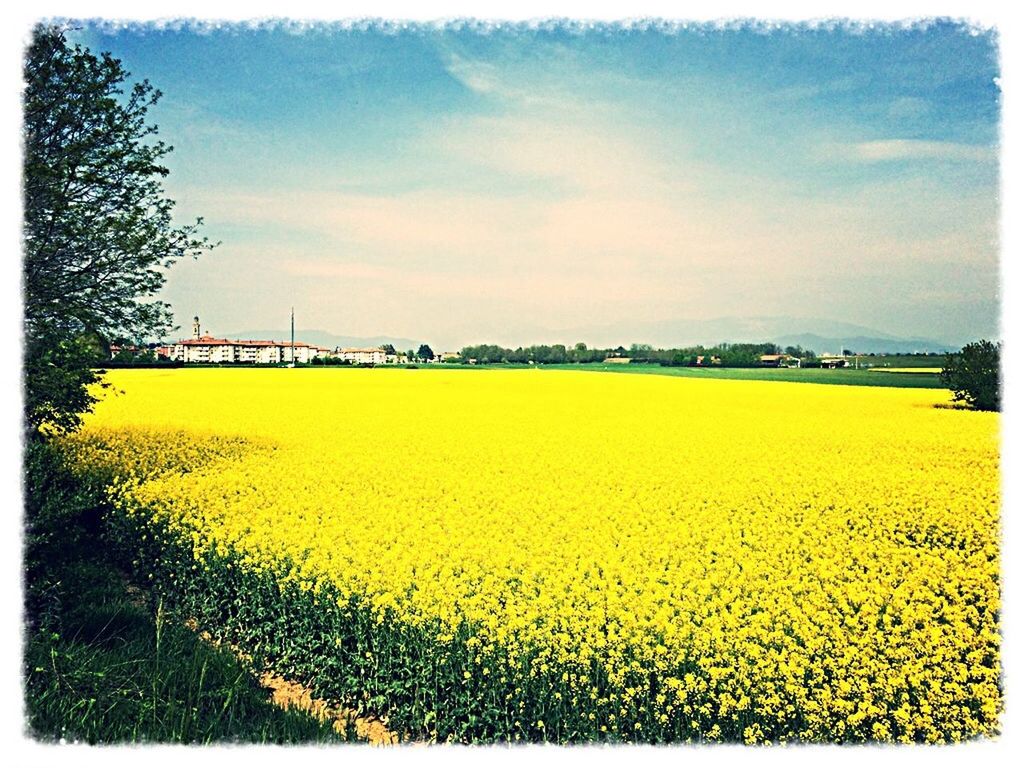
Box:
[56,367,1002,743]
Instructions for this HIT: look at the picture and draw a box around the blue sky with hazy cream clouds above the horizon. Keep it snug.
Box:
[68,18,999,348]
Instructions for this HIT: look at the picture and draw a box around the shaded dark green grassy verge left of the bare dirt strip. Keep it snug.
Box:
[23,445,354,744]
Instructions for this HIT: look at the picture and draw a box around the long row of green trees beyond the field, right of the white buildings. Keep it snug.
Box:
[459,342,816,368]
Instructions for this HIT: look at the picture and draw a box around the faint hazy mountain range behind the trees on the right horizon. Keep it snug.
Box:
[557,315,959,352]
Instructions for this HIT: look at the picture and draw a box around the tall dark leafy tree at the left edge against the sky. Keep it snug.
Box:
[23,26,214,436]
